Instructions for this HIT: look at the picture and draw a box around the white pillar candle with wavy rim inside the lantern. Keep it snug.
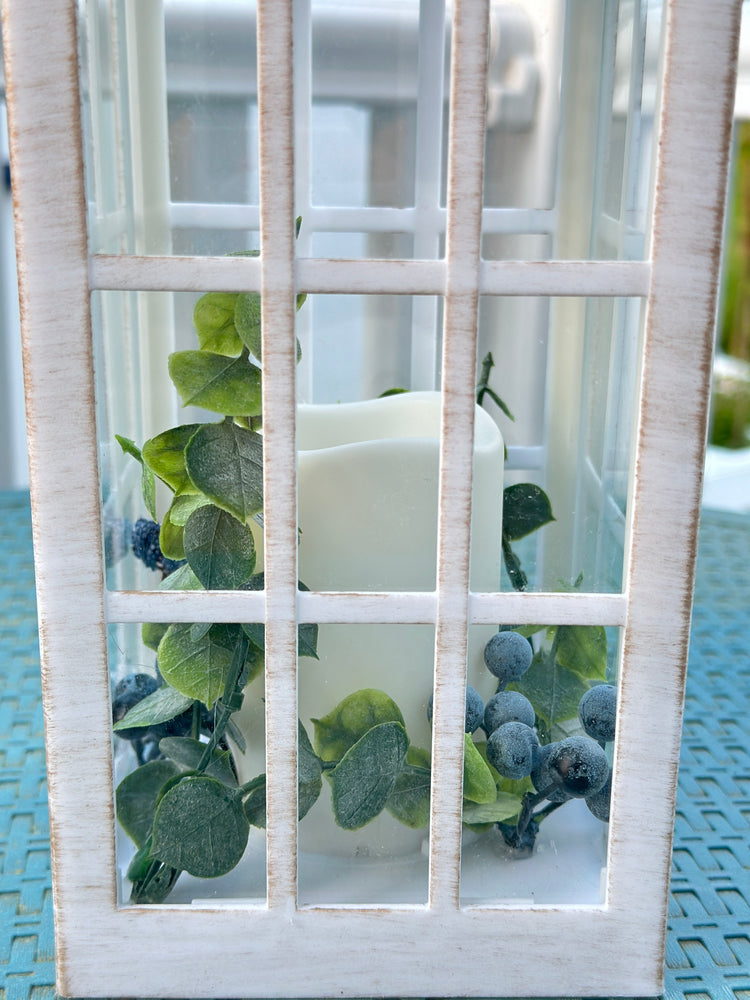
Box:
[238,392,503,855]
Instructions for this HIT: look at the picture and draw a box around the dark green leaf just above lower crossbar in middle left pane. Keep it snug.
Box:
[184,504,255,590]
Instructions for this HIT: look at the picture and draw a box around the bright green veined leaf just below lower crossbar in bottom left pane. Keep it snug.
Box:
[158,622,238,708]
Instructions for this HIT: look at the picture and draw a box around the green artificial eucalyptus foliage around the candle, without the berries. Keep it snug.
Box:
[114,242,606,903]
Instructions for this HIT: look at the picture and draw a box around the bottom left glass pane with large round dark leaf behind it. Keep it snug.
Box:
[109,623,266,905]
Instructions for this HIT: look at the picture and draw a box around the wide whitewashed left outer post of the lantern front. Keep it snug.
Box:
[2,0,115,992]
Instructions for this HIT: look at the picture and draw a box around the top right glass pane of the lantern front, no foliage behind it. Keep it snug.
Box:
[483,0,661,260]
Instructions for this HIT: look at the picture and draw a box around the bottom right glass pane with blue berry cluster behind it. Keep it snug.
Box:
[461,625,620,905]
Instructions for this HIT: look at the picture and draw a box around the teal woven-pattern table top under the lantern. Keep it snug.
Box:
[0,493,750,1000]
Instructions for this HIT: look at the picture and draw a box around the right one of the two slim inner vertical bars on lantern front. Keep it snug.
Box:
[429,0,489,909]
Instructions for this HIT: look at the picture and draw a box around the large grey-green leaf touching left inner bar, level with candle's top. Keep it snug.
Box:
[185,420,263,521]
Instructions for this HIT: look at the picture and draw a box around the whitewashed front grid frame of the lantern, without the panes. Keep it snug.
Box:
[2,0,741,997]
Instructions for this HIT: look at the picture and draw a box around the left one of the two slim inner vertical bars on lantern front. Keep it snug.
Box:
[258,0,297,909]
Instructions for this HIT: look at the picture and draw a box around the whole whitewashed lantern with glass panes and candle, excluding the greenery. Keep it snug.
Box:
[3,0,741,997]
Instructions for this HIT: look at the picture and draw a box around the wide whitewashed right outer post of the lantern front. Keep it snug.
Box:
[608,0,741,981]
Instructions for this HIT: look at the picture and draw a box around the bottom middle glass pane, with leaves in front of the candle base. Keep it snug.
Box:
[298,624,434,905]
